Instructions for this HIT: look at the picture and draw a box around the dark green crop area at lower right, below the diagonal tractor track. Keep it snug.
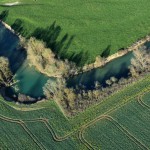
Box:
[82,91,150,150]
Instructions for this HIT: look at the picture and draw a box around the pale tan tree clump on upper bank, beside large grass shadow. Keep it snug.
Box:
[24,38,76,77]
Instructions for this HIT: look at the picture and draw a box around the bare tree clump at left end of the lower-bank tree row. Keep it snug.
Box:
[43,78,77,110]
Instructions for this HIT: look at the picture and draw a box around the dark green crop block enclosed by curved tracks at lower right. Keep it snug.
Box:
[84,118,143,150]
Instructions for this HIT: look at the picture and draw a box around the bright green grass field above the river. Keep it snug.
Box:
[0,0,150,64]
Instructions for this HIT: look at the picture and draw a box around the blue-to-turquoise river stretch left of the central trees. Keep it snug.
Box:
[0,24,49,98]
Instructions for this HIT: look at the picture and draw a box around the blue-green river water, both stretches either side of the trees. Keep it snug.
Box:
[0,23,150,98]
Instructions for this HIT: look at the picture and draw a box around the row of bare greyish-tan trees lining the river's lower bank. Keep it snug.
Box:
[43,49,150,115]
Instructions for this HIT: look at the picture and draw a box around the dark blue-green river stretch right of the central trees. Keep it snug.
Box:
[68,52,133,89]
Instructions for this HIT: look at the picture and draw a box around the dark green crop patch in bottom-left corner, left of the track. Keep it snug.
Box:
[0,118,38,150]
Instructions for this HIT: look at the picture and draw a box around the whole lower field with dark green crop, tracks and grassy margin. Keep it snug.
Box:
[0,75,150,150]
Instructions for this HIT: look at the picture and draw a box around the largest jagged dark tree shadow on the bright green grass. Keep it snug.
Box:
[30,21,91,65]
